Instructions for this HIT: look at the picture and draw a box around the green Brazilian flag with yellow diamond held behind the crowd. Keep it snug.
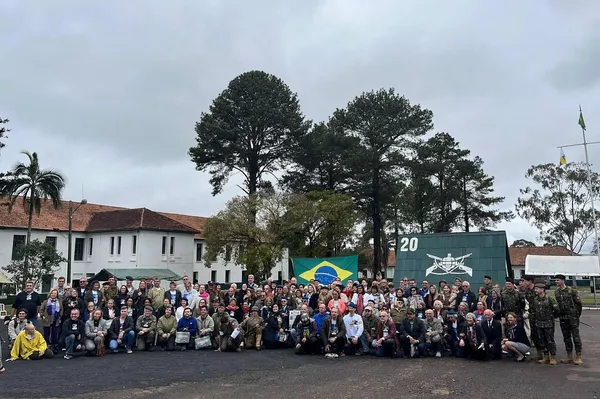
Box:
[292,255,358,285]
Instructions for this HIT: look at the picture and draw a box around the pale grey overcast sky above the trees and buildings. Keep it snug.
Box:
[0,0,600,250]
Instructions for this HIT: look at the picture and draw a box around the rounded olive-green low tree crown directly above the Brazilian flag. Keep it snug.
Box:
[280,191,357,257]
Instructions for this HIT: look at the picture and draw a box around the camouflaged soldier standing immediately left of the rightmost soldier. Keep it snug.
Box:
[533,283,558,365]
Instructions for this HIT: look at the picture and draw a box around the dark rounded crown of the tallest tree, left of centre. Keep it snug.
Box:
[189,71,310,195]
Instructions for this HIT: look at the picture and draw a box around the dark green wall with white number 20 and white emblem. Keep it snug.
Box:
[394,231,514,291]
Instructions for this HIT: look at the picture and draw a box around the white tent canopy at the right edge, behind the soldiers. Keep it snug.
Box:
[525,255,600,277]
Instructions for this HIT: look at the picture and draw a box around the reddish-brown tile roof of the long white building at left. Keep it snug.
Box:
[0,200,207,239]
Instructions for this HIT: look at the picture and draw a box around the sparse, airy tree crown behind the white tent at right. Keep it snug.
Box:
[516,163,600,253]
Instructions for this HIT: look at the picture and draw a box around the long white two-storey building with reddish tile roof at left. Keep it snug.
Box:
[0,201,288,292]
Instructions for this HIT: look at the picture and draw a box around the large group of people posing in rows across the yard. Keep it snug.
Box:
[0,275,583,372]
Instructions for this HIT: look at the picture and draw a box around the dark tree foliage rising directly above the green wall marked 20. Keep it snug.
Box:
[404,133,514,233]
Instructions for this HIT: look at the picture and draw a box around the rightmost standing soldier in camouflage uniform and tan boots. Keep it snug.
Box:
[554,274,583,365]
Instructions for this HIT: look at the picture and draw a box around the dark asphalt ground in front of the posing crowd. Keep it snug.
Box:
[0,311,600,399]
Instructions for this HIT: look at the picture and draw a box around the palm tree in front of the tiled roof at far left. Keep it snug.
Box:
[0,151,65,265]
